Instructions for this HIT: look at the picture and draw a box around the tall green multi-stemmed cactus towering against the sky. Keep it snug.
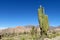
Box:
[38,6,49,40]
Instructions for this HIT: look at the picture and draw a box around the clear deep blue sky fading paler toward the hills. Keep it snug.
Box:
[0,0,60,28]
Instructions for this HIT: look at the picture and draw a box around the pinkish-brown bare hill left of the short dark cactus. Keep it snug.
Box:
[0,26,31,34]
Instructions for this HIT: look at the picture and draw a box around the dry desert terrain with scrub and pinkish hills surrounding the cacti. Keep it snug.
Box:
[0,26,60,40]
